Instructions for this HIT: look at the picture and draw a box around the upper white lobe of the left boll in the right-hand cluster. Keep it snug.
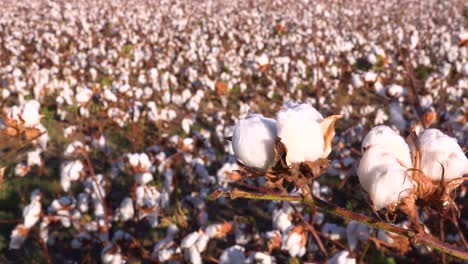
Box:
[362,125,412,168]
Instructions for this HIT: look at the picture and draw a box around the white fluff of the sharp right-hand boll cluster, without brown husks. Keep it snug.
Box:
[357,126,468,210]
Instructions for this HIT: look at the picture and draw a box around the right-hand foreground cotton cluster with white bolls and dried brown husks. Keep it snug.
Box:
[357,126,468,232]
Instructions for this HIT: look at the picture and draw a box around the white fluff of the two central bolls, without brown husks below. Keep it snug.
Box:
[232,102,340,171]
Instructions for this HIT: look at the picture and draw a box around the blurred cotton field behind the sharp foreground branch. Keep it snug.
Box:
[0,0,468,263]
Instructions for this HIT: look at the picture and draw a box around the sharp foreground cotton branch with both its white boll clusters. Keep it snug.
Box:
[212,103,468,261]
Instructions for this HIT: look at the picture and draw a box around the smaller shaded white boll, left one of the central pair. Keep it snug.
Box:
[232,114,276,171]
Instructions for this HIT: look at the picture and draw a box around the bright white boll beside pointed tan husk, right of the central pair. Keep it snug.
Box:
[276,104,325,165]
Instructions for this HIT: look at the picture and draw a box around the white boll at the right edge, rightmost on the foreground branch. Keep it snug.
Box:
[418,128,468,181]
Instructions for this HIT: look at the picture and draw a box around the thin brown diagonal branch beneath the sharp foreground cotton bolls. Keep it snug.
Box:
[212,188,468,260]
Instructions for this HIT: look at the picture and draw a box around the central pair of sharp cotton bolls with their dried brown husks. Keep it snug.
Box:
[231,102,341,192]
